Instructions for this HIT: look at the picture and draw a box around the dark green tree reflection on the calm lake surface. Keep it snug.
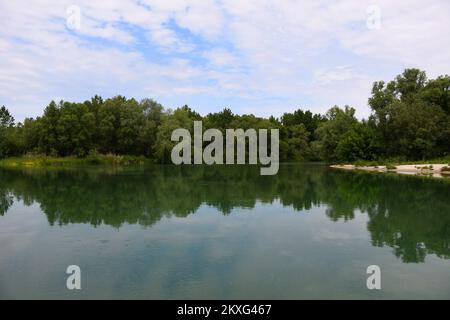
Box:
[0,165,450,262]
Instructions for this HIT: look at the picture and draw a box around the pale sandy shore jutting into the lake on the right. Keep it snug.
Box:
[331,164,450,178]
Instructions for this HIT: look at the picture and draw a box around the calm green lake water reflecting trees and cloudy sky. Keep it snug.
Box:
[0,165,450,299]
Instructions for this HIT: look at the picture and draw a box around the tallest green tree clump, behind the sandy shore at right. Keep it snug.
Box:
[369,69,450,160]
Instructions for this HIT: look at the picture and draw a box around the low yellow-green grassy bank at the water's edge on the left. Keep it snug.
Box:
[0,154,150,168]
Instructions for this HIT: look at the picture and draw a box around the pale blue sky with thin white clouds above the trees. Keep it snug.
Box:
[0,0,450,121]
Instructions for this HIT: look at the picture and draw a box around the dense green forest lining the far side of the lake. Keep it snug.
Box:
[0,69,450,163]
